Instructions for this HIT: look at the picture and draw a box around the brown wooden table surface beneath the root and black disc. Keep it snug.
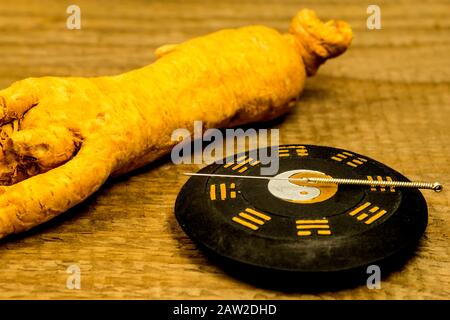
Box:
[0,0,450,299]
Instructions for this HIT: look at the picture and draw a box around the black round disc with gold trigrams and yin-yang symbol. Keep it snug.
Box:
[175,145,427,273]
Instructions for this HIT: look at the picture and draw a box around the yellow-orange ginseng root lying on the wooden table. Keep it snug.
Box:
[0,10,352,238]
